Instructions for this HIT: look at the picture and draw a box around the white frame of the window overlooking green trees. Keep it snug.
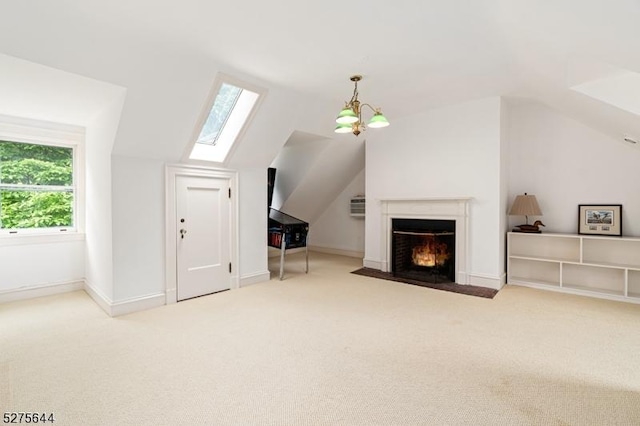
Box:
[0,115,86,241]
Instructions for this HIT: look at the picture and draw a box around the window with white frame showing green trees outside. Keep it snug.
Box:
[0,116,83,235]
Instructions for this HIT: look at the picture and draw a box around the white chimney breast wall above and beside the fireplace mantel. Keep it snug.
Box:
[365,98,505,287]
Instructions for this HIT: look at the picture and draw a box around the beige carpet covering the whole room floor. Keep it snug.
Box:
[0,253,640,426]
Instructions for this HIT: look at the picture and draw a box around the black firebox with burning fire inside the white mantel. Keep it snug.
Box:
[391,219,456,283]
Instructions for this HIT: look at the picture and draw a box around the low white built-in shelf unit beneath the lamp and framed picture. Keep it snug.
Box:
[507,232,640,303]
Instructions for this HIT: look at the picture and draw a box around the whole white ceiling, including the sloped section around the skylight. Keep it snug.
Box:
[0,0,640,195]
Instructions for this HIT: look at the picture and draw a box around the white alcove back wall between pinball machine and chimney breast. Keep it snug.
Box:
[309,169,365,257]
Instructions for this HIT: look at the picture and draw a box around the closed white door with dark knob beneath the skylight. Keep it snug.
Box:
[176,176,231,300]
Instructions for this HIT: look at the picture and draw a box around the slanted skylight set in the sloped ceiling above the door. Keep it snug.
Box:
[189,78,260,162]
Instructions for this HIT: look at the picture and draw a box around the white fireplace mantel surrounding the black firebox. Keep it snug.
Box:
[380,197,472,284]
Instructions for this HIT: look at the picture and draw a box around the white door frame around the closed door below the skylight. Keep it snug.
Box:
[165,164,240,305]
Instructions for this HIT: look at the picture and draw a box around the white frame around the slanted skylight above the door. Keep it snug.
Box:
[182,72,267,166]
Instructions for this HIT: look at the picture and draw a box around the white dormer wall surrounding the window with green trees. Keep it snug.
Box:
[0,54,125,300]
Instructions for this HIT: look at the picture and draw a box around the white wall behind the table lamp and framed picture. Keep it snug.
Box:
[509,102,640,236]
